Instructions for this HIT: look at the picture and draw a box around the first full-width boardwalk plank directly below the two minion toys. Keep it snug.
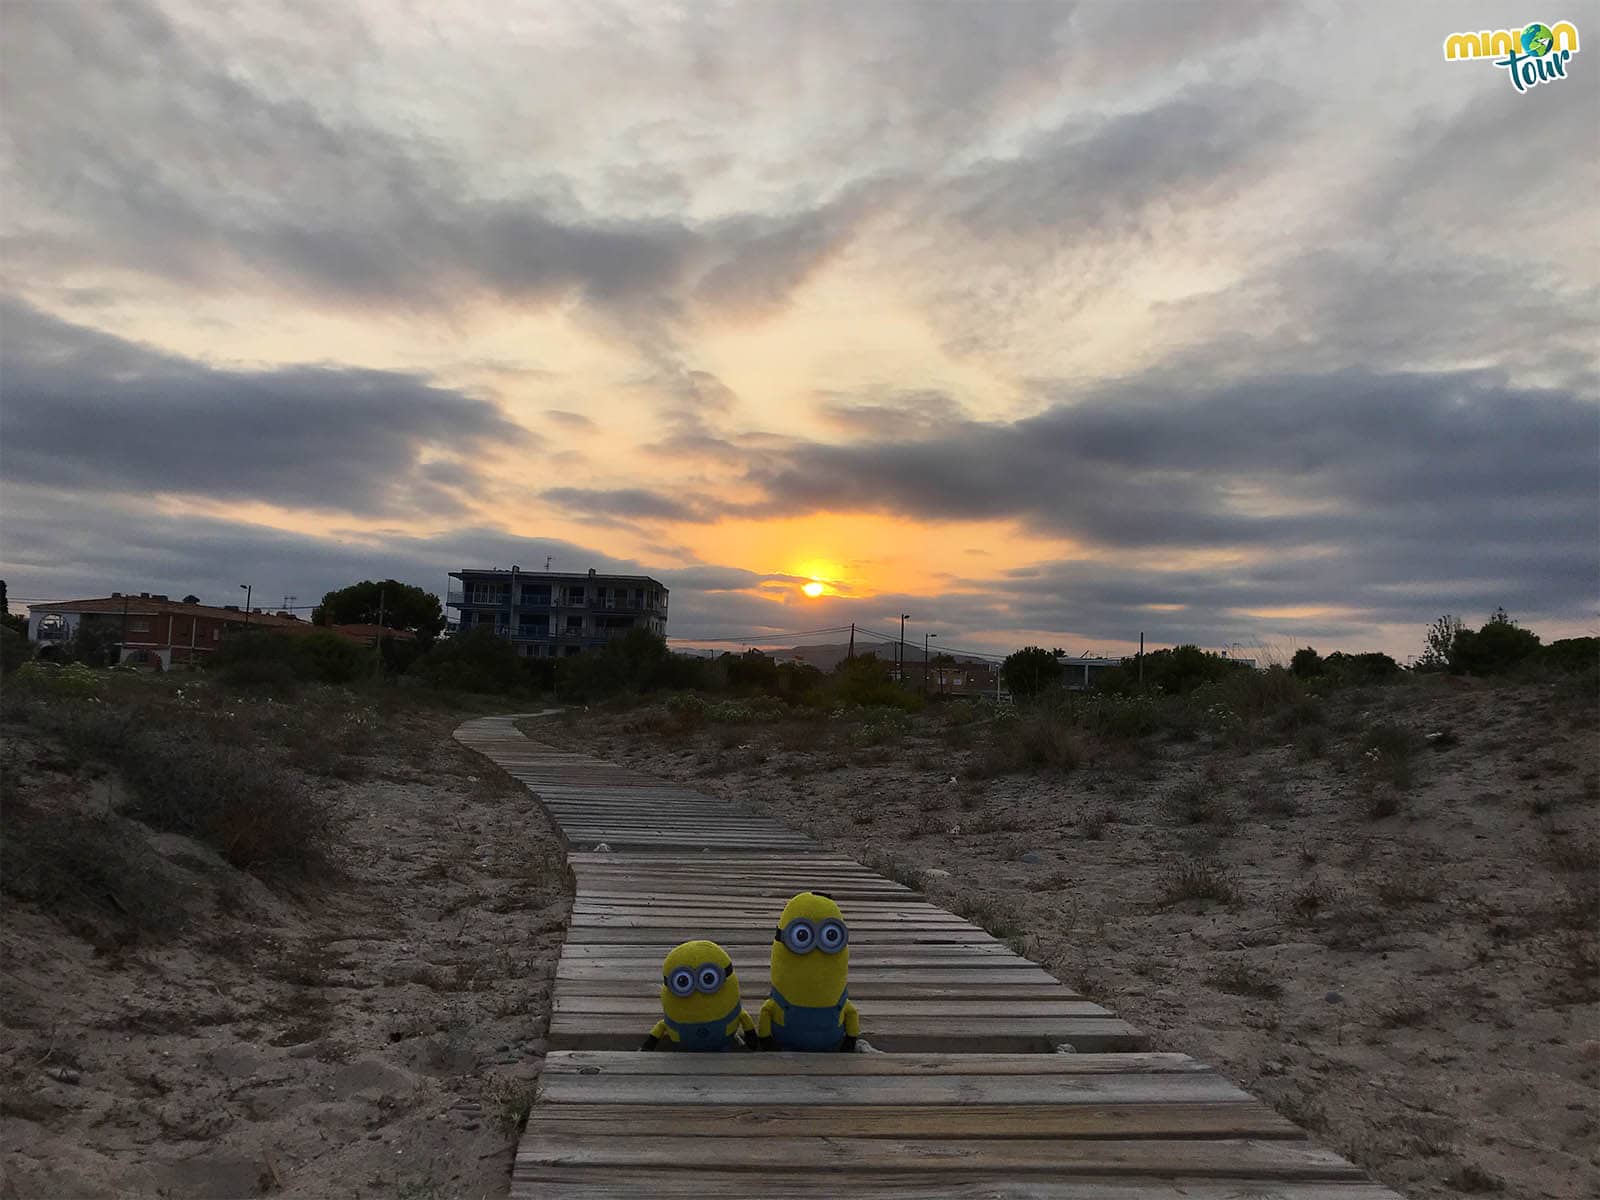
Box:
[542,1050,1216,1078]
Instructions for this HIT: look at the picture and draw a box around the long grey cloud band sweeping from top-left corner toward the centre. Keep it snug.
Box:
[5,5,889,344]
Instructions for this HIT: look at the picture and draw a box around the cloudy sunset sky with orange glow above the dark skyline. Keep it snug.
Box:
[0,0,1600,659]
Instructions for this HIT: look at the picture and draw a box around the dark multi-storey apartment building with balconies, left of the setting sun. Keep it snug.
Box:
[445,566,667,658]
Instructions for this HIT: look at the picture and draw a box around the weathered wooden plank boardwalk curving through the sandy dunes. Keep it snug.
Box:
[456,717,1397,1200]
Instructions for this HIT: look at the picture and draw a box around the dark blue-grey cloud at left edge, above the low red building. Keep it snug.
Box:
[0,304,531,514]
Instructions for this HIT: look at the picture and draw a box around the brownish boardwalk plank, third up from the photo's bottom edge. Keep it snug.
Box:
[530,1107,1306,1139]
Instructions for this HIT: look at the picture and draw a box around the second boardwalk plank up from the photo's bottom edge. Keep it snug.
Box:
[517,1131,1360,1189]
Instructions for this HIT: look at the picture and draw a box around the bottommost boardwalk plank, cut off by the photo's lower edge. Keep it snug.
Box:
[510,1177,1400,1200]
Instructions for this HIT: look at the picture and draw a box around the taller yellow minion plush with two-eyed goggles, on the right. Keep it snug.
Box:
[755,891,861,1051]
